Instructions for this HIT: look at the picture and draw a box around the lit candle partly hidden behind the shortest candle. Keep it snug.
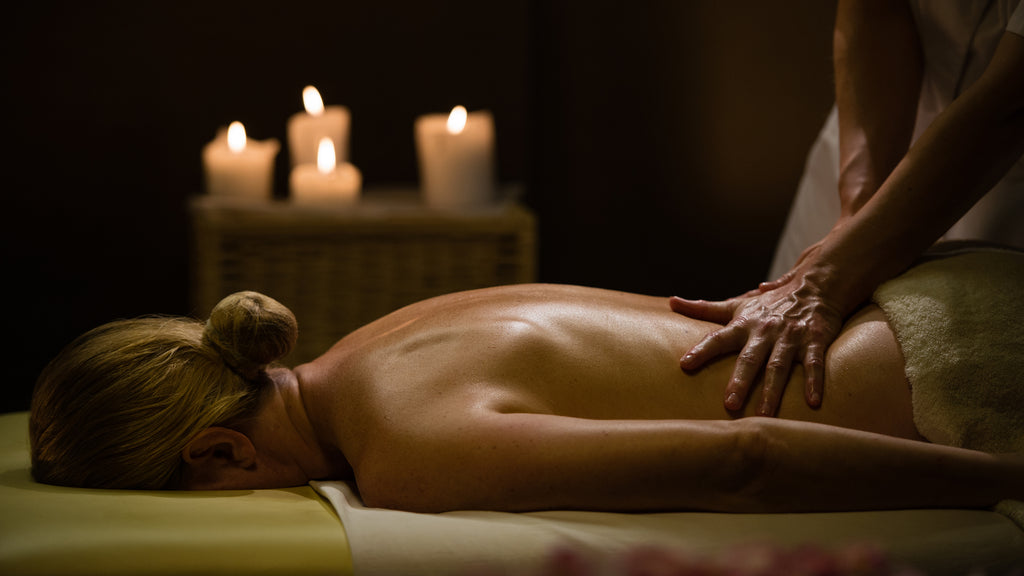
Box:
[288,86,351,166]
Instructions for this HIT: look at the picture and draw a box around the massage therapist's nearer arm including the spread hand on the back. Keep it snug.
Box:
[671,13,1024,415]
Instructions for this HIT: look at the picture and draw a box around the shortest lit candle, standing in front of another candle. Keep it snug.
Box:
[291,137,362,204]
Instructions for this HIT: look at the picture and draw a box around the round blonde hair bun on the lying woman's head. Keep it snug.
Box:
[203,291,299,378]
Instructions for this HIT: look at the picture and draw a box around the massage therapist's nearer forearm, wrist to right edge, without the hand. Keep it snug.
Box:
[811,34,1024,313]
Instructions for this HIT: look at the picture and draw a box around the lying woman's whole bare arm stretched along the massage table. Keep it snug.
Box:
[356,413,1024,512]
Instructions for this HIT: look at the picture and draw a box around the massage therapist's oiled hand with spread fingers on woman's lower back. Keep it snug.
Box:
[670,251,843,416]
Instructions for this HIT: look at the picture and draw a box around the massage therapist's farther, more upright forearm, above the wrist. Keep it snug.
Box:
[833,0,923,219]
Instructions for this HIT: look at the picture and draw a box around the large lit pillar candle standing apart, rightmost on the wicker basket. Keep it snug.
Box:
[415,106,497,209]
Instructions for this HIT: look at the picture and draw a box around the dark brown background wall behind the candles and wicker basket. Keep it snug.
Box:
[0,0,835,411]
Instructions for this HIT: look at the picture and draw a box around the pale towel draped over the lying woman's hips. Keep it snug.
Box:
[874,250,1024,452]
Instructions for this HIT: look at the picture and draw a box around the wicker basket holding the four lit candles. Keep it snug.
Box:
[190,192,536,365]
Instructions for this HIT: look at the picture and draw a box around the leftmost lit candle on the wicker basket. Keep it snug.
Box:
[203,122,281,199]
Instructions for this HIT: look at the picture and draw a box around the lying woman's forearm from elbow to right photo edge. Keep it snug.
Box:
[750,418,1024,512]
